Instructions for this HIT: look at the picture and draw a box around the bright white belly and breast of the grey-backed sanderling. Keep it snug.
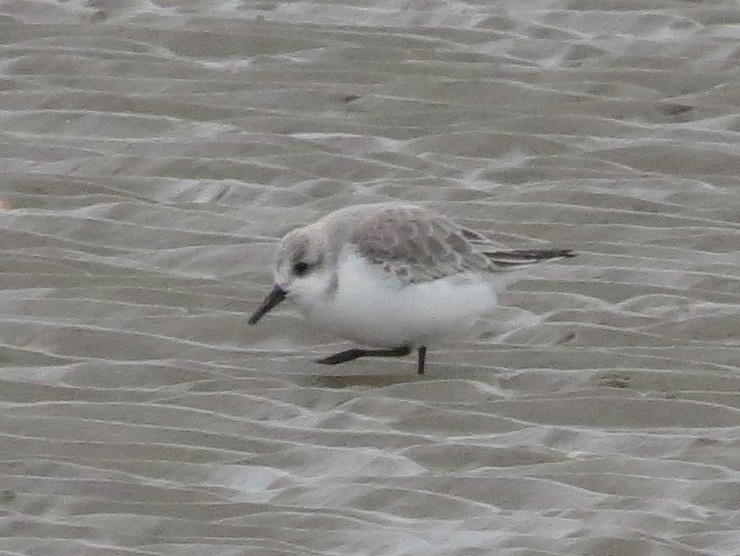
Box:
[301,256,496,347]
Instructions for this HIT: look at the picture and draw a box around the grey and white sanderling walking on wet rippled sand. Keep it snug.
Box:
[249,202,574,374]
